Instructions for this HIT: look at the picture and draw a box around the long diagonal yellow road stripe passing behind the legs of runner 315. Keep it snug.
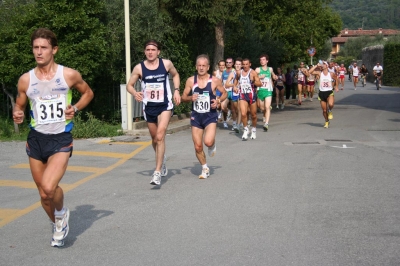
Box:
[0,141,151,228]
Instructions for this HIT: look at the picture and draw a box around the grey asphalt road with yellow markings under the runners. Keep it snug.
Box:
[0,82,400,266]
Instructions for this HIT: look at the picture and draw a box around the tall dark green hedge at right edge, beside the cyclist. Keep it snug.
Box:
[383,43,400,86]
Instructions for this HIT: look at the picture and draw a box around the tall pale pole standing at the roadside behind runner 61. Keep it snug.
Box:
[124,0,133,130]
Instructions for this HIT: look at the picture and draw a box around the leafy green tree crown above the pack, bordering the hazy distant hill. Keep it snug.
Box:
[245,0,342,62]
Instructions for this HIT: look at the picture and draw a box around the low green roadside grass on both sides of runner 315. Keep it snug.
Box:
[0,113,124,141]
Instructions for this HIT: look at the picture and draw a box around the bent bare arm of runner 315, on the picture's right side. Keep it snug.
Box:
[64,67,94,119]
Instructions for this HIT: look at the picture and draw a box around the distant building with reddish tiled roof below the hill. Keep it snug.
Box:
[331,28,400,58]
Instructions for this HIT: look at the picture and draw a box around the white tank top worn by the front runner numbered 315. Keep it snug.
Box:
[26,65,74,134]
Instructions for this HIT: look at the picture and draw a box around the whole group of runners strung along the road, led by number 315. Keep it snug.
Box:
[13,28,384,247]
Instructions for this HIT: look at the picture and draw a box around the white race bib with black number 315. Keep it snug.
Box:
[36,94,65,125]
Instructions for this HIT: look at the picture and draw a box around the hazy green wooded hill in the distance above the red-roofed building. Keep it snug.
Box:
[329,0,400,30]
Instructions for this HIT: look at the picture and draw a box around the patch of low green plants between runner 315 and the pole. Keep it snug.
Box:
[72,113,123,138]
